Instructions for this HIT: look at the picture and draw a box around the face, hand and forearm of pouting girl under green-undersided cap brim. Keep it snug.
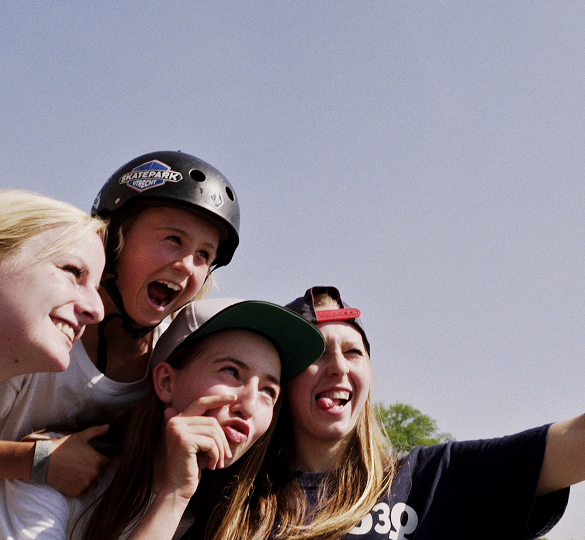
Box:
[129,330,280,540]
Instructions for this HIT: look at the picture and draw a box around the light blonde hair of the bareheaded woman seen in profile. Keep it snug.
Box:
[0,189,107,260]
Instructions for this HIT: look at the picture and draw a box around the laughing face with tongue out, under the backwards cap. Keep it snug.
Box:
[287,322,371,449]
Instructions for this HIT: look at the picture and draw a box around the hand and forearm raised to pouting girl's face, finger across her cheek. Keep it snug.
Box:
[128,395,235,540]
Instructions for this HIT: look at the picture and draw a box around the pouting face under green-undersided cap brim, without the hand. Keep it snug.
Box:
[159,330,280,466]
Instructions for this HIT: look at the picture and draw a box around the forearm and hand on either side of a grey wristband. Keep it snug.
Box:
[0,425,109,497]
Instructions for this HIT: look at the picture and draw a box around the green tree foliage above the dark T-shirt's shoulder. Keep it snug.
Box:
[376,403,453,455]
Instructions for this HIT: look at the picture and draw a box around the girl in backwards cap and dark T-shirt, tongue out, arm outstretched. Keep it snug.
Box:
[183,287,585,540]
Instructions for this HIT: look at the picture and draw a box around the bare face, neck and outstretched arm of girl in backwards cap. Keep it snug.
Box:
[288,322,585,496]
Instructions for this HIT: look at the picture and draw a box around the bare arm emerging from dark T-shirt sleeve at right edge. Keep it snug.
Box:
[536,415,585,496]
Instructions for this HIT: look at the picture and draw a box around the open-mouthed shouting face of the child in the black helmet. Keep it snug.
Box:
[117,207,220,326]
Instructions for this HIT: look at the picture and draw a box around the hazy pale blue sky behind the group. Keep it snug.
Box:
[0,0,585,540]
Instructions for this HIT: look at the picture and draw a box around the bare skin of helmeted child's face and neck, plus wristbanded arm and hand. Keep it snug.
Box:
[0,207,220,496]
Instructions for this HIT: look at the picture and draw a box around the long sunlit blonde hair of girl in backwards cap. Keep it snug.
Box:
[200,294,397,540]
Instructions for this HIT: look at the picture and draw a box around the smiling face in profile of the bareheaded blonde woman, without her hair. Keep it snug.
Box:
[0,227,105,378]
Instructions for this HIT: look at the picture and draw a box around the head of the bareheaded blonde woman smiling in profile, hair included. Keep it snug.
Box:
[0,189,106,381]
